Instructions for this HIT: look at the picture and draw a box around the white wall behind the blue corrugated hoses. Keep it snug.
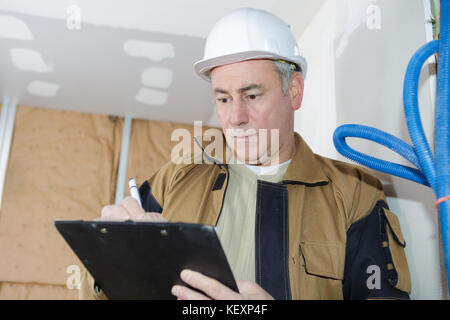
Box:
[293,0,446,299]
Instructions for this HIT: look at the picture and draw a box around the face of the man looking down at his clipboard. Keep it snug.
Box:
[211,60,294,164]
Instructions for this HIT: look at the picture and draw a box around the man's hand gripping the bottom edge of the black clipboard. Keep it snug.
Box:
[172,269,273,300]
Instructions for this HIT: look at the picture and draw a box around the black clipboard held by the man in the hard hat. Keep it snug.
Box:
[54,220,239,300]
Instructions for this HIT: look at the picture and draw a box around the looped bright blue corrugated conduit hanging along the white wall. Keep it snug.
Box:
[333,0,450,296]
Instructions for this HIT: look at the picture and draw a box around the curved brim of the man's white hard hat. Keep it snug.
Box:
[194,51,306,81]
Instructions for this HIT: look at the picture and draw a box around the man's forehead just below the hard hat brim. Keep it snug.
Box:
[211,60,280,89]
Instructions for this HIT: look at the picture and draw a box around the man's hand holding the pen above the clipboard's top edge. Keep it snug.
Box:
[100,197,167,222]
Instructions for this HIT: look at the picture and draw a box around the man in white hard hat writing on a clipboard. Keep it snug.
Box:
[80,9,411,299]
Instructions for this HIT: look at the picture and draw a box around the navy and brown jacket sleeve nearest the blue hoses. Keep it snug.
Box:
[343,171,411,299]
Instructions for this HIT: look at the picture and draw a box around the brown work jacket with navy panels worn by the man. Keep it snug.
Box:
[79,133,411,299]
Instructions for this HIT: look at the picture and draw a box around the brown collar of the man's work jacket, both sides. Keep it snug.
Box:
[194,132,329,185]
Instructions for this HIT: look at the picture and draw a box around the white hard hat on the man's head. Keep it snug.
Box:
[194,8,307,81]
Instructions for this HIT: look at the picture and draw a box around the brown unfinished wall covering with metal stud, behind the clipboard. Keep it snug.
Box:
[0,106,201,299]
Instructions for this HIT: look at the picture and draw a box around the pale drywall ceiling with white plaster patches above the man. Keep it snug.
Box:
[0,0,324,126]
